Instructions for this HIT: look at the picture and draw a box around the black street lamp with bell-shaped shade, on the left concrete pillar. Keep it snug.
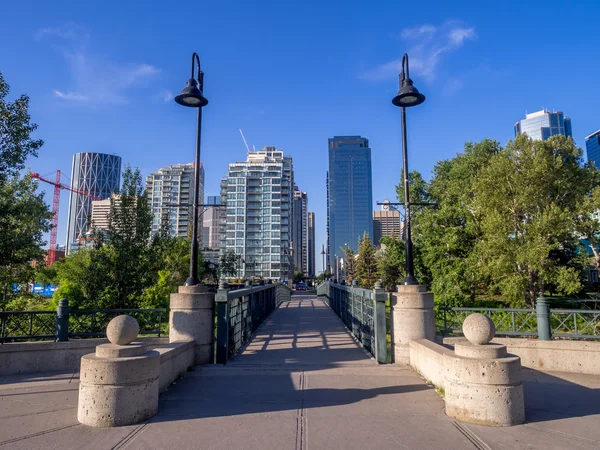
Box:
[175,52,208,286]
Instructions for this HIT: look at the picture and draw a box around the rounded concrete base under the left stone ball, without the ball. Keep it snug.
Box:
[77,344,160,427]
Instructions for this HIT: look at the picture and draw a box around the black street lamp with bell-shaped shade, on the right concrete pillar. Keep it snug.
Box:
[392,53,425,284]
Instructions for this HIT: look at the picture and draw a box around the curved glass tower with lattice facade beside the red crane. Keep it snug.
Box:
[67,153,121,253]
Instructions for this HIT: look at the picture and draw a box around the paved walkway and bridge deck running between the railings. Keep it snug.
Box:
[0,295,600,450]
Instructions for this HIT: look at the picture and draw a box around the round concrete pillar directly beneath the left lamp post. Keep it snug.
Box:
[169,286,215,365]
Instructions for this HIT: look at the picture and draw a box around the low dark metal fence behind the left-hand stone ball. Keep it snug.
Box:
[0,299,167,343]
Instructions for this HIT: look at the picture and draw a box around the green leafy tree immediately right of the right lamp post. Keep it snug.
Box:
[416,139,502,306]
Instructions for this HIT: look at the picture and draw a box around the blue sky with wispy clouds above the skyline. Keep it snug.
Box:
[0,0,600,270]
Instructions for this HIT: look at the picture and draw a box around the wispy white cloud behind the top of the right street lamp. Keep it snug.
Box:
[362,22,476,81]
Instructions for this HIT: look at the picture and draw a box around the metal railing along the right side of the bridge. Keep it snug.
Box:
[317,281,388,363]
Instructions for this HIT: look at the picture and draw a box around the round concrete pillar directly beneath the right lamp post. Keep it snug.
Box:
[390,285,435,364]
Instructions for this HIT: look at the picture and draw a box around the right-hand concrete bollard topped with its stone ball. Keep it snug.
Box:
[444,314,525,427]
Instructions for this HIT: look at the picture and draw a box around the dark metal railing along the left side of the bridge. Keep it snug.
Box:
[215,283,291,364]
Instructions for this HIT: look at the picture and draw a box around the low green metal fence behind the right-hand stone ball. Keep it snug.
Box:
[436,302,600,339]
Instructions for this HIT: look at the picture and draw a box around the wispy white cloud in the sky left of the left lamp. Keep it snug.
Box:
[36,24,160,106]
